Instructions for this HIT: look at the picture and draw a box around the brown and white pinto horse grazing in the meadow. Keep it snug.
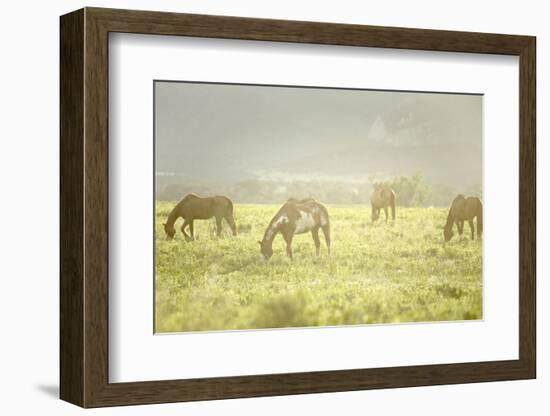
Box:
[258,198,330,260]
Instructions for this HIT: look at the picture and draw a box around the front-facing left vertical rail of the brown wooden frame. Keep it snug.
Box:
[84,11,109,406]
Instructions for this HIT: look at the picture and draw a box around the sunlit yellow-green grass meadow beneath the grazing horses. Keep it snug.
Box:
[155,202,482,332]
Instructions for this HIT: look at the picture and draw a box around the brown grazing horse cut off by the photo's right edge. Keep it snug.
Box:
[443,195,483,241]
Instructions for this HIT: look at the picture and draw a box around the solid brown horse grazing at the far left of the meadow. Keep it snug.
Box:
[164,194,237,241]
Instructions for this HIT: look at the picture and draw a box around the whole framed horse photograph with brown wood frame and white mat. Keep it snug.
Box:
[60,8,536,407]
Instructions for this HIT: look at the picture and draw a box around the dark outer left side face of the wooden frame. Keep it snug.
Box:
[59,10,85,406]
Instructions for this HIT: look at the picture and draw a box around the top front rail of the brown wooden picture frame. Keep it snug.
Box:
[86,8,529,55]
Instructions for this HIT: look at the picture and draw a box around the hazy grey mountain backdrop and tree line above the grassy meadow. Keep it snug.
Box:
[155,82,482,206]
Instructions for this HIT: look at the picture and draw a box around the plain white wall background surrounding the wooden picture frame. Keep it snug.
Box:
[0,0,550,416]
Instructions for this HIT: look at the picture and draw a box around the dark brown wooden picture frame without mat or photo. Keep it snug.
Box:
[60,8,536,407]
